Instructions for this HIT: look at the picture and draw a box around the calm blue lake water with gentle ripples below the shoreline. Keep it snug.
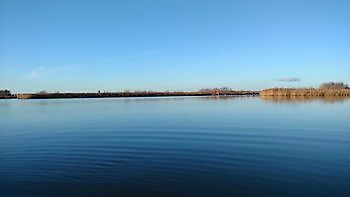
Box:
[0,97,350,197]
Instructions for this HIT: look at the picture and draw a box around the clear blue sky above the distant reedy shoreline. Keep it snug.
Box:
[0,0,350,92]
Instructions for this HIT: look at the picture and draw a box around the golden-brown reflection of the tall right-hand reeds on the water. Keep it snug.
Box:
[260,96,350,104]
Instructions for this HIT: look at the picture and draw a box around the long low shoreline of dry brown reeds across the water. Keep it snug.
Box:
[0,88,350,99]
